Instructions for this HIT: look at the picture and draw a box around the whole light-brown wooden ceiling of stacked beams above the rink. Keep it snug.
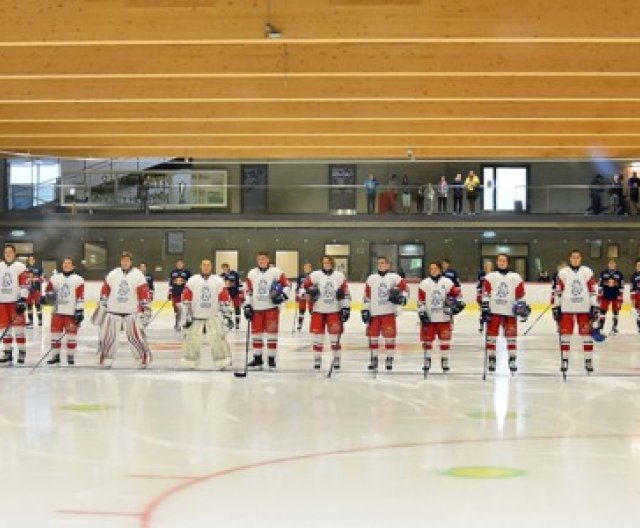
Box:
[0,0,640,159]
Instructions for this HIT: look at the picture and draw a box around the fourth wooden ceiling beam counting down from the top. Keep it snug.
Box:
[0,101,640,121]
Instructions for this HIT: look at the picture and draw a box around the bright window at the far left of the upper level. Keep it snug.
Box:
[8,158,60,211]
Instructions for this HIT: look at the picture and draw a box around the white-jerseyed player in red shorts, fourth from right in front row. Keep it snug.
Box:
[360,257,409,370]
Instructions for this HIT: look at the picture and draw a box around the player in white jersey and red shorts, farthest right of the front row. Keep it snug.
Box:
[552,249,600,372]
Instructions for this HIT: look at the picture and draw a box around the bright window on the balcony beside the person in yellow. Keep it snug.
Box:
[482,166,529,211]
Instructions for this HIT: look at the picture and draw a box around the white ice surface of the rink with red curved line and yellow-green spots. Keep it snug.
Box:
[0,290,640,528]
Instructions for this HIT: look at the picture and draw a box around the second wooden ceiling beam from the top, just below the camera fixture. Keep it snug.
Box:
[0,40,640,75]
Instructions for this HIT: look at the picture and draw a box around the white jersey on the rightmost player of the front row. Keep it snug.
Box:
[553,266,598,313]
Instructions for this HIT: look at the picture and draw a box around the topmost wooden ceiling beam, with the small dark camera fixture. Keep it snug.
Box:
[0,0,640,41]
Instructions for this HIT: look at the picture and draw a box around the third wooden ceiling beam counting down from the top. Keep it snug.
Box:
[0,77,640,103]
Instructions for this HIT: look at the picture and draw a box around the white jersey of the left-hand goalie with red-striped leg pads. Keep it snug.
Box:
[100,268,149,314]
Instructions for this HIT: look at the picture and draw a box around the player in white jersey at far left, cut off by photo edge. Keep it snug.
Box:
[0,244,29,365]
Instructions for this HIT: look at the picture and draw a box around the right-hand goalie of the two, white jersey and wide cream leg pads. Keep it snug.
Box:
[182,258,233,370]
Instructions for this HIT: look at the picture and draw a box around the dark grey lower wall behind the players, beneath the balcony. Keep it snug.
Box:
[0,222,640,281]
